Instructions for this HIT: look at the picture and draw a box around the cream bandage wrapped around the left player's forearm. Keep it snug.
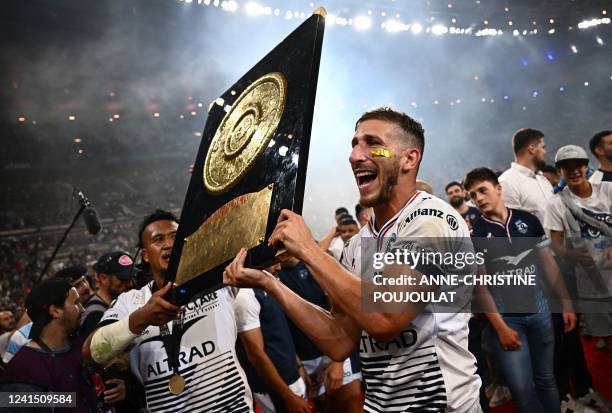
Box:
[89,317,138,365]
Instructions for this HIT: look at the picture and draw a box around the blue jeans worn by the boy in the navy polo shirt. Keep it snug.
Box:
[487,313,561,413]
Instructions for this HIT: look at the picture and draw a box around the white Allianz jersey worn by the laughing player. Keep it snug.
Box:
[341,191,481,413]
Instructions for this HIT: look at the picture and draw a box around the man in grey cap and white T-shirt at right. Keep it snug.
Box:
[544,145,612,358]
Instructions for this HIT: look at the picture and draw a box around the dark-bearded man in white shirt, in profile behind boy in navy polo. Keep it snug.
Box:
[499,129,553,221]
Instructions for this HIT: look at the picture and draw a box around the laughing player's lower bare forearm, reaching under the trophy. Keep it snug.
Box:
[264,277,358,361]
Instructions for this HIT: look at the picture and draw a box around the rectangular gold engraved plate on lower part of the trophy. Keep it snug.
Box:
[175,185,274,286]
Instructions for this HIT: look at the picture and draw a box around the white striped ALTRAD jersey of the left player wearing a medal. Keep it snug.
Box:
[99,282,259,413]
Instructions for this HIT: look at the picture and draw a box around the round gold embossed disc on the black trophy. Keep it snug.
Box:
[203,72,287,195]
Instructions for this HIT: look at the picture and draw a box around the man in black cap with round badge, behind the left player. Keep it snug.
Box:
[81,251,134,337]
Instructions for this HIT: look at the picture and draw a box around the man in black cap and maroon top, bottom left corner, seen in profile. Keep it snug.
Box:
[0,278,97,412]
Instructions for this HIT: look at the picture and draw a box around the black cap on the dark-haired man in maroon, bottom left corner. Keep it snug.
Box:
[26,277,72,339]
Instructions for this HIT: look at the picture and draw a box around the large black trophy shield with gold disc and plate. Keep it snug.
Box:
[166,9,325,304]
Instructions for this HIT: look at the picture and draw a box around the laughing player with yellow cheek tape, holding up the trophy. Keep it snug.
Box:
[224,108,481,413]
